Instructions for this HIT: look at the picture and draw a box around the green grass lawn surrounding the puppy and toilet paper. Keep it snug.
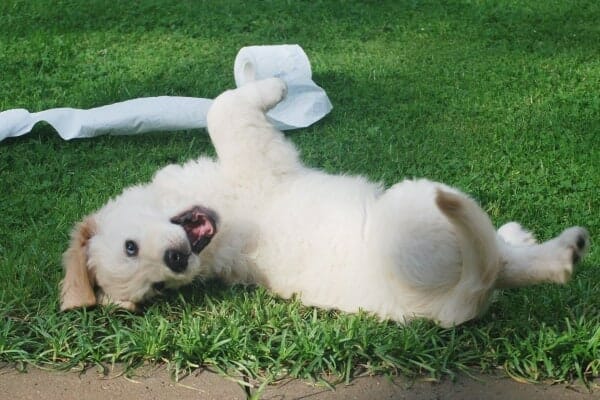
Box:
[0,0,600,390]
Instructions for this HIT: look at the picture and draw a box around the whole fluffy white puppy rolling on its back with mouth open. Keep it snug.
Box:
[62,79,588,326]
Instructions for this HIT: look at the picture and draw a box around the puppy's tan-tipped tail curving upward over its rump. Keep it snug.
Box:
[435,189,500,297]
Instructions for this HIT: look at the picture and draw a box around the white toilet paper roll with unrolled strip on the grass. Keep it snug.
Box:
[0,45,331,141]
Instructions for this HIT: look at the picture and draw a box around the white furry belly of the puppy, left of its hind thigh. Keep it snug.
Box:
[246,173,410,312]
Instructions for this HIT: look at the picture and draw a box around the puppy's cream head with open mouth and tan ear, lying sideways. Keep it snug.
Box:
[61,187,217,311]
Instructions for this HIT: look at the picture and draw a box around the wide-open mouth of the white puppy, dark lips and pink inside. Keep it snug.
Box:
[171,206,218,254]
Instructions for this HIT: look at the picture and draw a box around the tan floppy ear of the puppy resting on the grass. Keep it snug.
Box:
[60,216,96,311]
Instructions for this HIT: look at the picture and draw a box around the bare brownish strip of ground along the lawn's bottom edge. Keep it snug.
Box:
[0,366,600,400]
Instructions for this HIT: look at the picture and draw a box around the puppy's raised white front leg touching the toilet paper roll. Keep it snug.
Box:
[207,78,300,182]
